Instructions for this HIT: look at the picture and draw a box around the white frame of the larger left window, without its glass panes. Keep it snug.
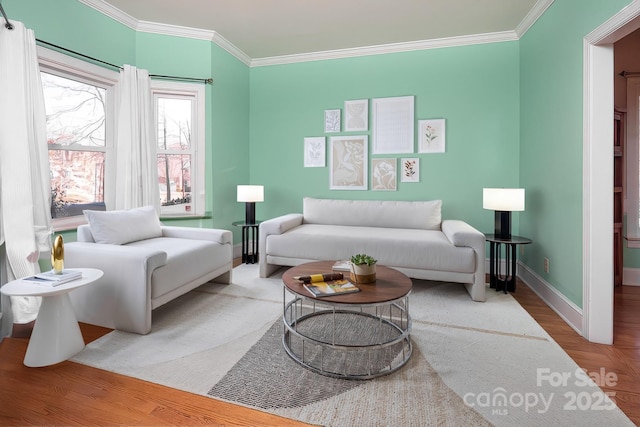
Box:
[37,46,119,231]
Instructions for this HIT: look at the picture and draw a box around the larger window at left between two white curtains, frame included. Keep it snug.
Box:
[38,47,118,230]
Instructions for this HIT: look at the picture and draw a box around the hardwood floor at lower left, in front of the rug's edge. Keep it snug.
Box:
[0,324,307,426]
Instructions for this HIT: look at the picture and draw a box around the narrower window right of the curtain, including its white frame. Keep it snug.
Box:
[151,81,204,217]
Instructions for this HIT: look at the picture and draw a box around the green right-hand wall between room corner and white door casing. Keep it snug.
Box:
[519,0,630,307]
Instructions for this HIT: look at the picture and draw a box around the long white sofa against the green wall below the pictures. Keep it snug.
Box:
[259,197,486,301]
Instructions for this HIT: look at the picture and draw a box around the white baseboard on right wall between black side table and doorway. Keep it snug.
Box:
[516,261,584,336]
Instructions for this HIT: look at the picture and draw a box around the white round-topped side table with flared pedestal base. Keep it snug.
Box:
[0,268,103,367]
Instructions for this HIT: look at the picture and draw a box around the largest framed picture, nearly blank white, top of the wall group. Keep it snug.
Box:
[372,96,414,154]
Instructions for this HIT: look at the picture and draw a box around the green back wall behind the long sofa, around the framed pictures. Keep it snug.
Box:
[250,42,520,232]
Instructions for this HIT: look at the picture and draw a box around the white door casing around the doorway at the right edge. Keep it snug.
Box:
[582,2,640,344]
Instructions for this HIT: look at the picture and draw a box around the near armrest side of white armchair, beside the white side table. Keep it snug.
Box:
[64,242,167,334]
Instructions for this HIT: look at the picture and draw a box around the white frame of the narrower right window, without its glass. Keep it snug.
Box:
[151,80,206,219]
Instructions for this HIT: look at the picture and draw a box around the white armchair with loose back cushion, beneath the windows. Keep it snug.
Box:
[64,208,233,334]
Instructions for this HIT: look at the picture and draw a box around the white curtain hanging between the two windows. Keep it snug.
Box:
[115,65,160,212]
